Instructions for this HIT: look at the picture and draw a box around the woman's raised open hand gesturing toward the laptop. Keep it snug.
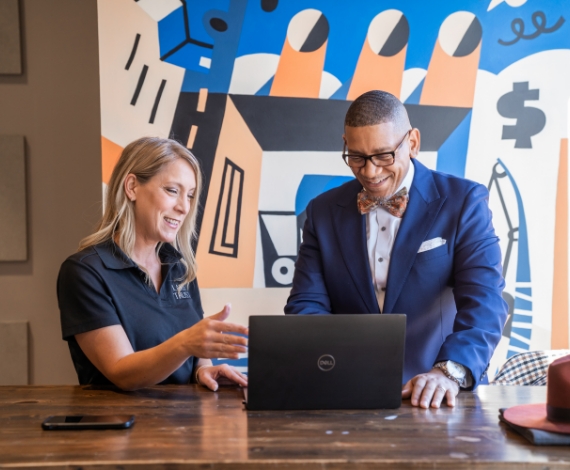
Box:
[184,304,249,359]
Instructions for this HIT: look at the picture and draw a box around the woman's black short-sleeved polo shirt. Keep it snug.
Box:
[57,240,204,385]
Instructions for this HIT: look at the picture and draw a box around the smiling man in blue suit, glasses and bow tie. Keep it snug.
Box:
[285,91,507,408]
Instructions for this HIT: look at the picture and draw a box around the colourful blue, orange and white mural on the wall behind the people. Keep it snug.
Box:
[98,0,570,371]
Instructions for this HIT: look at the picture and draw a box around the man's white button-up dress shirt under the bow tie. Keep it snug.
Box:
[366,162,415,311]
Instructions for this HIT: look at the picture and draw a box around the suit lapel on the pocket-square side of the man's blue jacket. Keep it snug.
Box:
[383,160,447,313]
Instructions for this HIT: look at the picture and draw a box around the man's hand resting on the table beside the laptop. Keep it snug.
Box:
[402,369,459,408]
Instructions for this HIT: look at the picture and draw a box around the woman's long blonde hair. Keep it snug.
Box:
[79,137,202,290]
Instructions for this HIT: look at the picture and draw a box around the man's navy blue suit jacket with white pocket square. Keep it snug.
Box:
[285,160,507,387]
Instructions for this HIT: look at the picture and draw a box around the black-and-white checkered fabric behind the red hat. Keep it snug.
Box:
[491,349,570,385]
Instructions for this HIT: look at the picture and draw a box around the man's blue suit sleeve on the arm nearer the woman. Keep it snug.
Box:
[285,201,331,315]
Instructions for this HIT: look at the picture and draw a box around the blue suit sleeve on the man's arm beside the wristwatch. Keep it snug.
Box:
[436,185,508,388]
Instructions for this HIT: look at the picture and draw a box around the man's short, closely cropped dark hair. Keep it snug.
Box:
[344,90,407,127]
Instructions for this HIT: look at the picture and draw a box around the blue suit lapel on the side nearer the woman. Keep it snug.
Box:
[332,182,380,313]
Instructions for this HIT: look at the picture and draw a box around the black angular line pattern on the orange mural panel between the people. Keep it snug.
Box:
[209,157,245,258]
